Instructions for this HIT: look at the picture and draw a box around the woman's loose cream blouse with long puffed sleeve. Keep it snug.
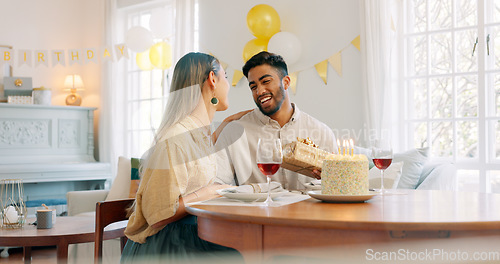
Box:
[125,117,216,243]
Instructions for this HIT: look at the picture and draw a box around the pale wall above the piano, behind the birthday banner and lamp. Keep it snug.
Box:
[0,0,104,157]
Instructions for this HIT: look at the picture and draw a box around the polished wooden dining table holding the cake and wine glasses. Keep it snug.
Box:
[186,190,500,263]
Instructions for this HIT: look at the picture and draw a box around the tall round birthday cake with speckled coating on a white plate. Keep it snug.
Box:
[321,154,368,195]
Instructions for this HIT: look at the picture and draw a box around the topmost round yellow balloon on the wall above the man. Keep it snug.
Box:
[247,4,281,39]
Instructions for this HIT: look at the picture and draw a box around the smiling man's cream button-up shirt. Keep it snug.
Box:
[215,104,337,190]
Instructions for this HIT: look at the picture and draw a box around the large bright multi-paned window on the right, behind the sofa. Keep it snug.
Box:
[401,0,500,192]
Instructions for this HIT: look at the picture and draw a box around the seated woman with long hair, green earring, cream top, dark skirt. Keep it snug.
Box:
[121,53,243,263]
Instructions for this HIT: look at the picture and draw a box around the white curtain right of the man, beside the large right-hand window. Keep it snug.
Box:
[360,0,396,143]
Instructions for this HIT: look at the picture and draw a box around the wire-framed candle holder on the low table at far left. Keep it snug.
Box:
[0,179,27,228]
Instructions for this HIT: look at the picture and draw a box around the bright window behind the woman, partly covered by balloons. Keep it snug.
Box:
[116,0,198,157]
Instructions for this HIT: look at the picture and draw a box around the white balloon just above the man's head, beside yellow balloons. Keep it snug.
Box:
[267,31,302,65]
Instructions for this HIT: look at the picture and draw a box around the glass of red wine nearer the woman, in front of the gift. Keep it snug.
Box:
[256,138,283,206]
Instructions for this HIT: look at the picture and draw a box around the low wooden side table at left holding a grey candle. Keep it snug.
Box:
[0,216,127,263]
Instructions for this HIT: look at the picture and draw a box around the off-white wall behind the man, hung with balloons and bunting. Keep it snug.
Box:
[200,0,364,142]
